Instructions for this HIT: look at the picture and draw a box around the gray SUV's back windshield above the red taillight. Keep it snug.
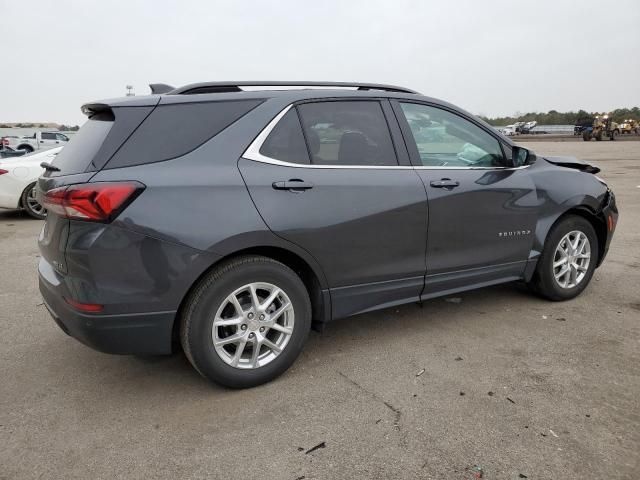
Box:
[52,114,113,176]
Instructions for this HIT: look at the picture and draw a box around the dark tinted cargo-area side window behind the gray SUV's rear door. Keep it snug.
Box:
[105,100,262,168]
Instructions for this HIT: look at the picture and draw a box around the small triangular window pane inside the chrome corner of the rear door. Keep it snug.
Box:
[260,108,309,163]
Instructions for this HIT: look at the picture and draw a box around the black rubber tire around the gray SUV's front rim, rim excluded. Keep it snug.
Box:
[530,215,599,301]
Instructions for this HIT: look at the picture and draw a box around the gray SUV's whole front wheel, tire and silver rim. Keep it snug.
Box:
[531,215,598,301]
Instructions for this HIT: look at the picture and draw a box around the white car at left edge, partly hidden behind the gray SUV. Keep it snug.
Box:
[0,147,62,219]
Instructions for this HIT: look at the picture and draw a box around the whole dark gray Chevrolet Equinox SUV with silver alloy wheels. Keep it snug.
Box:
[38,82,618,387]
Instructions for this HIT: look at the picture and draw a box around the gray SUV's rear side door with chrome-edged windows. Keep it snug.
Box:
[239,99,427,318]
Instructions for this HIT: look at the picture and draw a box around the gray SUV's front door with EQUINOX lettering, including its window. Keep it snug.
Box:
[394,101,539,297]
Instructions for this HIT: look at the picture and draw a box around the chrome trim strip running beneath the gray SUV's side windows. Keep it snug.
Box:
[242,103,531,170]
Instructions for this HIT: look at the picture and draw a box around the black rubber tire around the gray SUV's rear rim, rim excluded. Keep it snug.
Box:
[180,255,311,388]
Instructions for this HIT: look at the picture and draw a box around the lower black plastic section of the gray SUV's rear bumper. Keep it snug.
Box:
[39,264,176,355]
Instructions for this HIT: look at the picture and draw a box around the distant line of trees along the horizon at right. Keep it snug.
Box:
[480,107,640,126]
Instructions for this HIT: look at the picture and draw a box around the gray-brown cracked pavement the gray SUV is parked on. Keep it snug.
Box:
[0,142,640,480]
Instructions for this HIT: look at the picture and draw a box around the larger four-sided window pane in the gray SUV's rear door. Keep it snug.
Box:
[298,101,398,166]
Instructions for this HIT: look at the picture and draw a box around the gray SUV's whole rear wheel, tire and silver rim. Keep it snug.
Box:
[180,256,311,388]
